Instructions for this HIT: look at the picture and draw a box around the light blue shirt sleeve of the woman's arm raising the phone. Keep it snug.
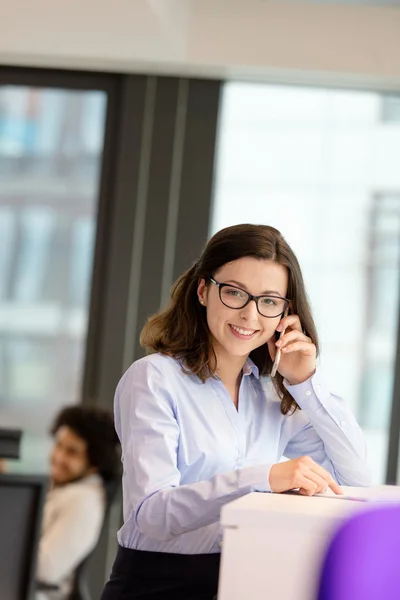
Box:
[283,371,370,486]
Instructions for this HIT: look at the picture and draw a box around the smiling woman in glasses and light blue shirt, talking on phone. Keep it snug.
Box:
[103,225,368,600]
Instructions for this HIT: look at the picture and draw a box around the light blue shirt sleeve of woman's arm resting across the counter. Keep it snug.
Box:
[115,362,272,541]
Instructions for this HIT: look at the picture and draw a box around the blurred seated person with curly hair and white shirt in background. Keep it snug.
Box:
[37,406,120,600]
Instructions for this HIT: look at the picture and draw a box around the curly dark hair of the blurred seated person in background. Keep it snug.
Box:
[51,405,121,482]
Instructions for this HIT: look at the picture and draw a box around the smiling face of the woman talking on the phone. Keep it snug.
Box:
[198,256,288,358]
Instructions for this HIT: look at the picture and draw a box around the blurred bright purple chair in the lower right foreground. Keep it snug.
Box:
[318,504,400,600]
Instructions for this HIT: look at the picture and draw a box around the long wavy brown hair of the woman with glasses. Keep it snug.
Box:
[140,224,318,415]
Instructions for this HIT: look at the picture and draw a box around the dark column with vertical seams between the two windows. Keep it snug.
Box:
[84,75,220,598]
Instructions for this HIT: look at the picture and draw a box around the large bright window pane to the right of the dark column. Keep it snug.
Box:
[211,83,400,483]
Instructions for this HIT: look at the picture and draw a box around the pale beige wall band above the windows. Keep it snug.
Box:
[0,0,400,89]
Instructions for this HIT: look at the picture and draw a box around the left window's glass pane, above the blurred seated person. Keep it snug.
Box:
[0,86,107,470]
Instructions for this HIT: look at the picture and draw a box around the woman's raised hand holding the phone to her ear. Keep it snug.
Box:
[268,315,317,385]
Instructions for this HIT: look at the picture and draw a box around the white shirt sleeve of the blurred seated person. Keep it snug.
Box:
[37,489,104,585]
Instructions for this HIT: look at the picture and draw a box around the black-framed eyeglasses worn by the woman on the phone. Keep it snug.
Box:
[209,277,289,319]
